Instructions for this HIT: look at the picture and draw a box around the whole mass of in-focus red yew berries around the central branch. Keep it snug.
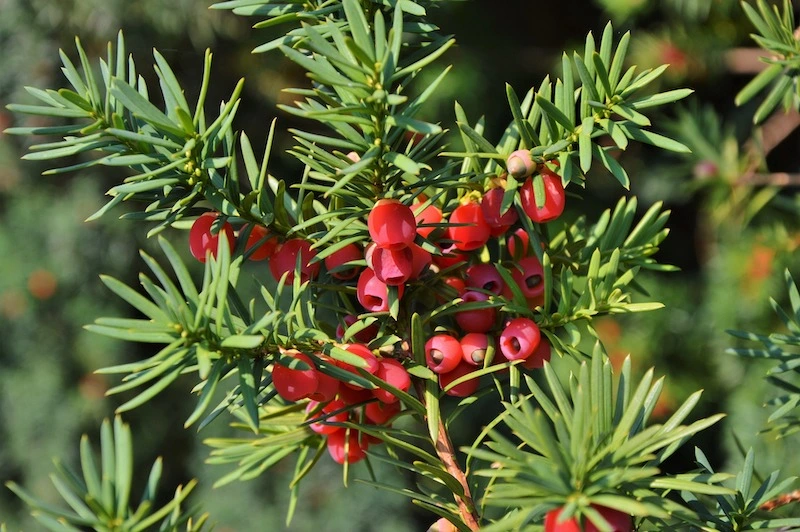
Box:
[189,150,565,462]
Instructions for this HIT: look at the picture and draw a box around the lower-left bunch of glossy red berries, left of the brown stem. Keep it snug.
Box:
[272,344,411,464]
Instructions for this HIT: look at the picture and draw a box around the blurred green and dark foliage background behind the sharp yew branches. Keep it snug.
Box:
[0,0,800,531]
